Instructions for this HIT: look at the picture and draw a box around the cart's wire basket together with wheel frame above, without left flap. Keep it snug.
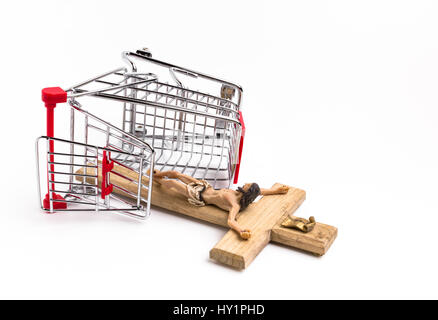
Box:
[69,52,242,187]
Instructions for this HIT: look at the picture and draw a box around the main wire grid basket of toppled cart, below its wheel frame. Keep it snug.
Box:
[66,81,241,187]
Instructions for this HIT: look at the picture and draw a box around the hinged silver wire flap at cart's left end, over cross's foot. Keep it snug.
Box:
[36,136,153,218]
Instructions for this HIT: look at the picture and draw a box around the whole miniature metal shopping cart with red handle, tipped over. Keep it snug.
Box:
[36,49,245,218]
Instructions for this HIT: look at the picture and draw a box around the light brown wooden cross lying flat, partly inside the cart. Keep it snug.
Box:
[78,166,338,269]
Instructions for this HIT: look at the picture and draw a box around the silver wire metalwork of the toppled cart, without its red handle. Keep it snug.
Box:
[36,47,242,218]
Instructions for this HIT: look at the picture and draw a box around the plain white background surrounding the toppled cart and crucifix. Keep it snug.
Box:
[0,0,438,299]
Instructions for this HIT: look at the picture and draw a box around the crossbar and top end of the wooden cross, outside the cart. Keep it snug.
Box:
[210,184,337,269]
